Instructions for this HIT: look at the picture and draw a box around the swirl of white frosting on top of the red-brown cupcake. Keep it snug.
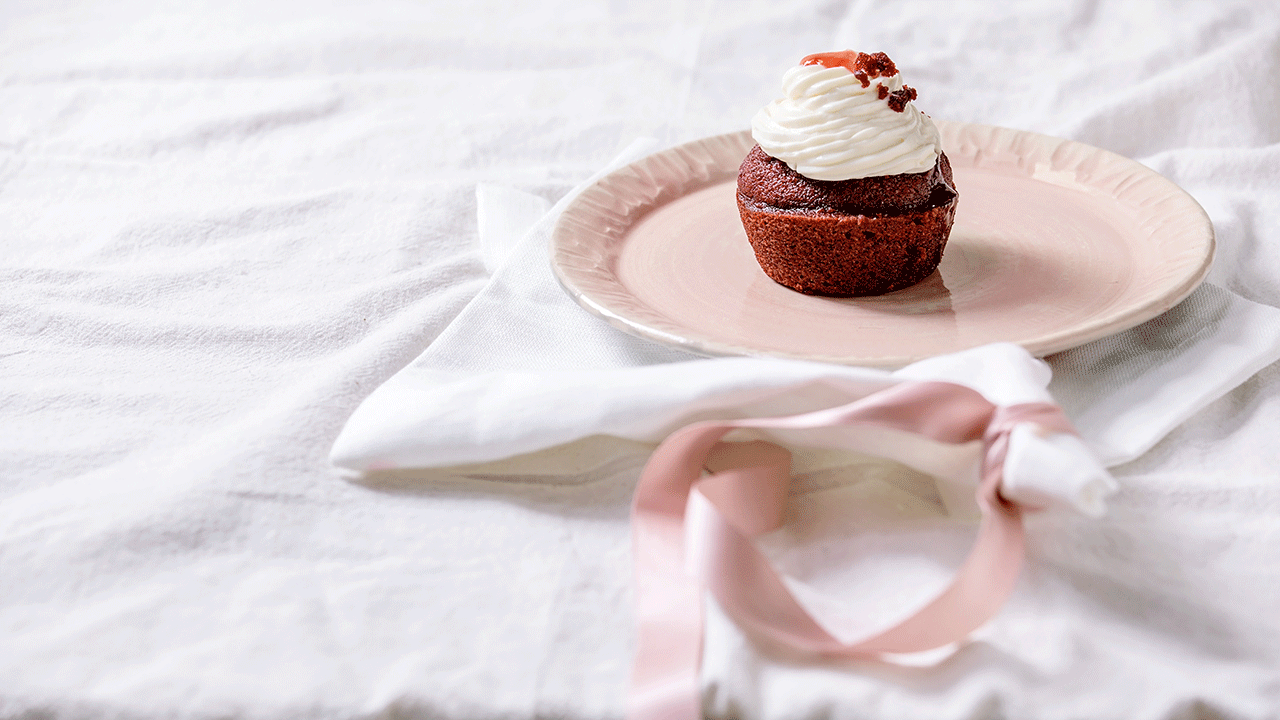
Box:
[751,60,942,181]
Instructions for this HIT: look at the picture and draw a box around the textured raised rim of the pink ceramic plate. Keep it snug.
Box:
[548,119,1216,366]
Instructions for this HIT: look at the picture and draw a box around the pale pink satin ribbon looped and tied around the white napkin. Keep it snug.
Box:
[627,382,1075,720]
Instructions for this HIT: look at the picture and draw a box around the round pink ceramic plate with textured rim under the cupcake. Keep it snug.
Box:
[550,122,1213,366]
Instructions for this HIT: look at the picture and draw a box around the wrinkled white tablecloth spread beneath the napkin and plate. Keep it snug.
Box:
[0,0,1280,719]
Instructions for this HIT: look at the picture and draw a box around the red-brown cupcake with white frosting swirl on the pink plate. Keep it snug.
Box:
[737,50,959,297]
